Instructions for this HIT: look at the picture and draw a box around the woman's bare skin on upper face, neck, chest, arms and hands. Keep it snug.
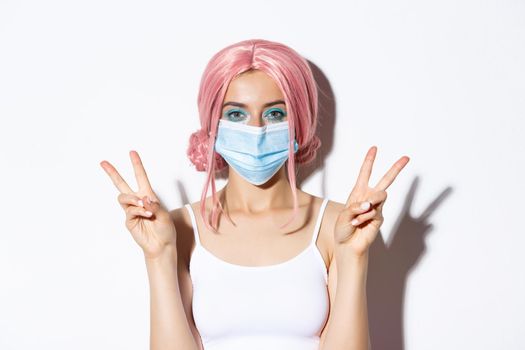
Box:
[100,71,409,350]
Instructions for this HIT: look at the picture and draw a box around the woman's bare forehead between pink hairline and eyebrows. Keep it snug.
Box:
[224,70,284,105]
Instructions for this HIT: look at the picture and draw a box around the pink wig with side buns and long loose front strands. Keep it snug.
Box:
[187,39,321,232]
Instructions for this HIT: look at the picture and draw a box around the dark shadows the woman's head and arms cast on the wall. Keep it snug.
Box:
[170,61,452,350]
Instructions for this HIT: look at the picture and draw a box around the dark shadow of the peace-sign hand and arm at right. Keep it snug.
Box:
[367,177,452,350]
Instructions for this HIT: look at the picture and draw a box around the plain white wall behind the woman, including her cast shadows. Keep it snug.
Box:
[0,0,525,350]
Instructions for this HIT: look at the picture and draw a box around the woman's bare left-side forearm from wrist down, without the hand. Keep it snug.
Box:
[145,248,200,350]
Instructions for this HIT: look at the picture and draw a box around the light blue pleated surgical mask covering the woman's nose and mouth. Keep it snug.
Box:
[215,119,299,185]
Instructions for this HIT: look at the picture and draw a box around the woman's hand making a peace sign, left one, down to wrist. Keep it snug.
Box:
[100,151,176,258]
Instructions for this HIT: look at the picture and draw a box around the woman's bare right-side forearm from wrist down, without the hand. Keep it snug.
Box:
[320,249,370,350]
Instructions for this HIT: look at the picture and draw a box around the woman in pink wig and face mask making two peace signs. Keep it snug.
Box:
[101,40,409,350]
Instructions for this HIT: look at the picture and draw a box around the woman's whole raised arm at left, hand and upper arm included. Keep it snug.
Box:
[100,151,202,350]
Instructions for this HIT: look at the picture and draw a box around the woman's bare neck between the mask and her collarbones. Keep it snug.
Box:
[224,163,293,214]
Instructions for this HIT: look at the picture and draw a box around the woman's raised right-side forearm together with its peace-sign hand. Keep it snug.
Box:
[321,146,409,350]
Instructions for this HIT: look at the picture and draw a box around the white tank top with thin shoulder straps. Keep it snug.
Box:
[185,199,330,350]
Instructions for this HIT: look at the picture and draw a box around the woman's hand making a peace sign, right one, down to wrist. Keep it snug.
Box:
[334,146,410,257]
